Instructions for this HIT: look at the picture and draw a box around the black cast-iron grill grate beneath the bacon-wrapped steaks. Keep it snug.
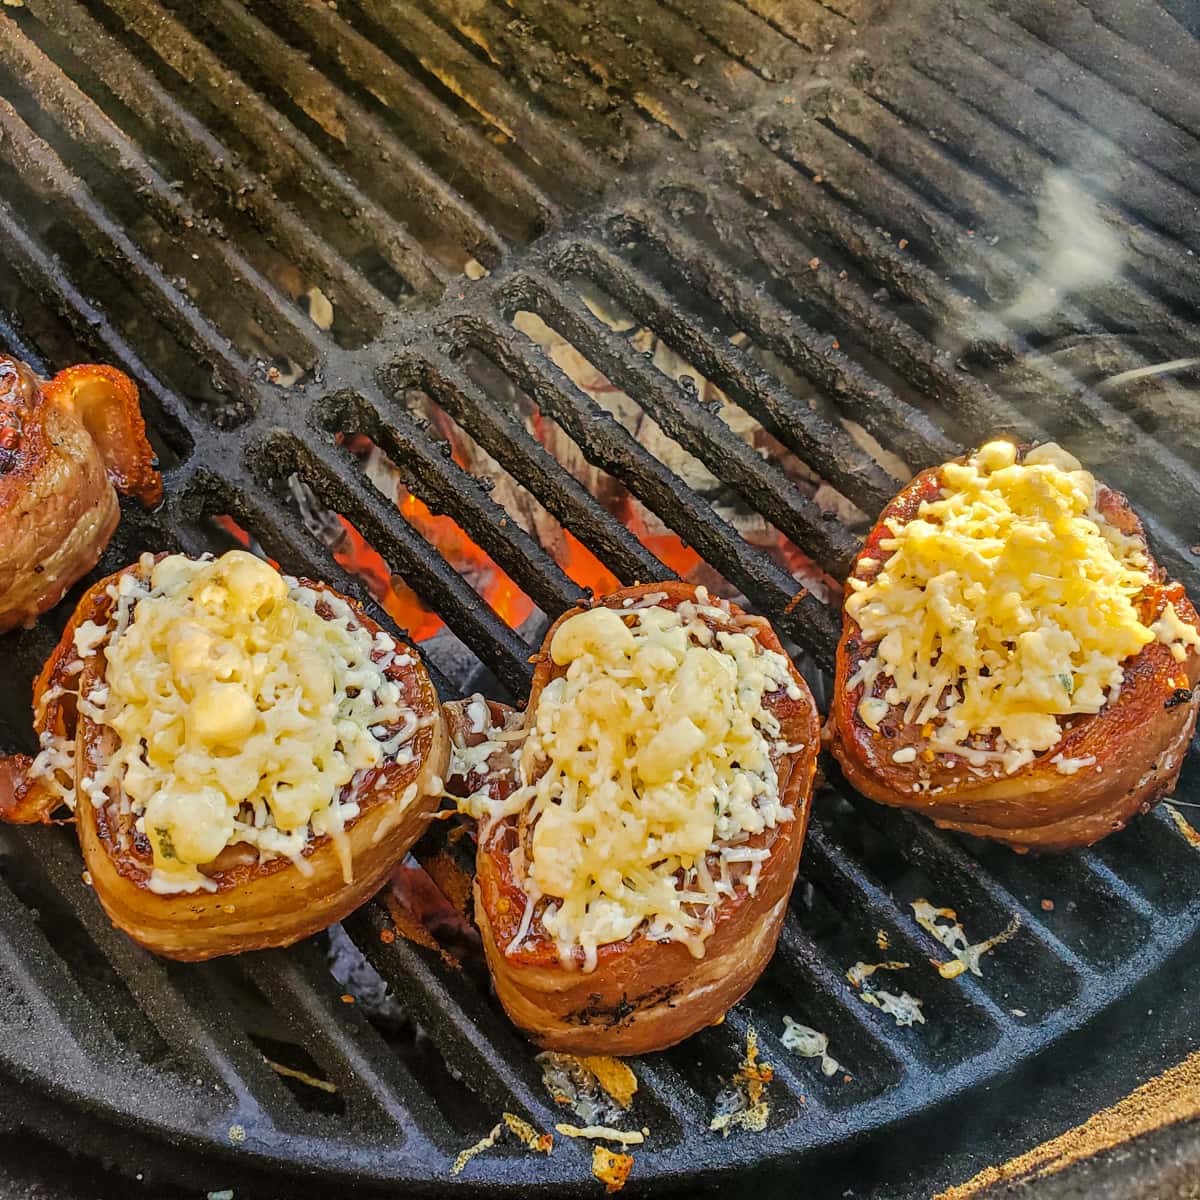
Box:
[0,0,1200,1195]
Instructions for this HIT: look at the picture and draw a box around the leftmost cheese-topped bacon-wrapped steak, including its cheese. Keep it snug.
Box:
[0,551,449,960]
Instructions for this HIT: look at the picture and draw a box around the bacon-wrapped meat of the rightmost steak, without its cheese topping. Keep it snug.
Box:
[827,460,1200,851]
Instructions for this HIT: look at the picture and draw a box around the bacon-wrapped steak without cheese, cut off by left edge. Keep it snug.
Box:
[0,356,162,632]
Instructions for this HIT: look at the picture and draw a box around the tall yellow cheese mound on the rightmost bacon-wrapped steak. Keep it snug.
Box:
[846,442,1200,772]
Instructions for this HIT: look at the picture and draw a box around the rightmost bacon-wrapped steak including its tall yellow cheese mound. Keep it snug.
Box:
[826,443,1200,850]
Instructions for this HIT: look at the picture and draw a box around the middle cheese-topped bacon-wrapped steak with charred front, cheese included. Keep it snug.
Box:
[450,583,817,1055]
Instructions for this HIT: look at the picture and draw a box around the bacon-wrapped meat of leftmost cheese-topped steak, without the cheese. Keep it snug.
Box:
[0,564,449,961]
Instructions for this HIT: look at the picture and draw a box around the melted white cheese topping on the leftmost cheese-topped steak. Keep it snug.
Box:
[83,551,418,893]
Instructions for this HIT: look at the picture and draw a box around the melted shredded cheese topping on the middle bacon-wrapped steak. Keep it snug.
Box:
[465,595,800,970]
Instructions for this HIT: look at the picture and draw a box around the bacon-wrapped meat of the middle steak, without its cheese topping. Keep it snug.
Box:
[463,583,818,1055]
